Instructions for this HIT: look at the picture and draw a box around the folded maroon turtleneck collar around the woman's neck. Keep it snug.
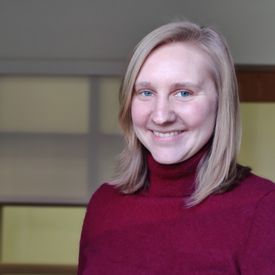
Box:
[146,146,208,197]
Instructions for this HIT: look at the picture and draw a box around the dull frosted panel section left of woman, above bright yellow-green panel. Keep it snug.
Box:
[0,76,122,204]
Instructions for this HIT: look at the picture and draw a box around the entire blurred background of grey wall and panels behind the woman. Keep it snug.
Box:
[0,0,275,274]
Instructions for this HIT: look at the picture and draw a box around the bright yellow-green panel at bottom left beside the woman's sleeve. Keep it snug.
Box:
[2,207,85,264]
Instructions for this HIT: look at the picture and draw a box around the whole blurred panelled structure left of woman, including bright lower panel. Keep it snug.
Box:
[0,75,123,274]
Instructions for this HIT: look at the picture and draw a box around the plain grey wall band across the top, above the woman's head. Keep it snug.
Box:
[0,0,275,73]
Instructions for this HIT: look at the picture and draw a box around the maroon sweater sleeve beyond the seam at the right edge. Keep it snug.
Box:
[240,191,275,275]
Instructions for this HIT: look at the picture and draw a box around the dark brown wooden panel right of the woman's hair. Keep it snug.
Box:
[237,66,275,102]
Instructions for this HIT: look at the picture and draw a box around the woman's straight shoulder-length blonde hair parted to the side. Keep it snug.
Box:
[113,21,246,207]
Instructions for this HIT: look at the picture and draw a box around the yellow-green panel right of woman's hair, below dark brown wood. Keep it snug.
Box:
[239,103,275,181]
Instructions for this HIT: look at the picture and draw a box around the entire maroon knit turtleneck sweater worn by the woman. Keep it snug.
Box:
[78,153,275,275]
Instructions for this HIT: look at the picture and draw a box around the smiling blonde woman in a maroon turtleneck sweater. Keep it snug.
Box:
[78,22,275,275]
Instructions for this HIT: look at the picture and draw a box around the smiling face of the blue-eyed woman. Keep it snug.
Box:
[131,42,217,164]
